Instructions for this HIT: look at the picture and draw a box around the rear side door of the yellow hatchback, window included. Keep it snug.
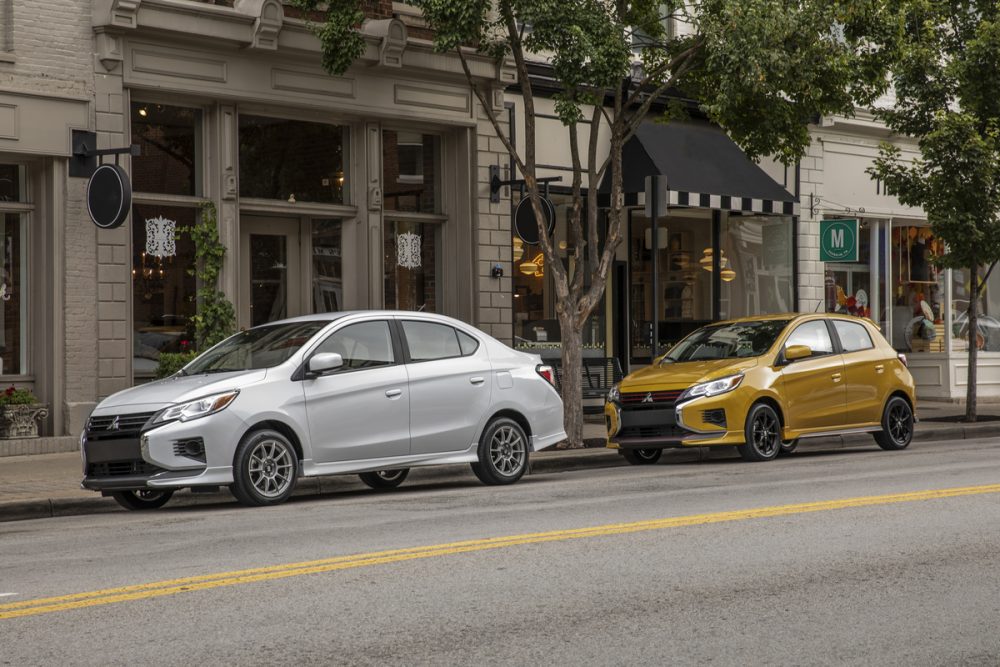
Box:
[832,319,887,426]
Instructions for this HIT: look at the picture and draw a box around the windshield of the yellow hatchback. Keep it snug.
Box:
[660,320,789,364]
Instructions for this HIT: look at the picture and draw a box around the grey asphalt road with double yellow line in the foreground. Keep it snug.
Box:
[0,440,1000,665]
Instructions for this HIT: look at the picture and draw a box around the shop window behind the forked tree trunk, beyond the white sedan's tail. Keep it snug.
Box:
[511,194,605,356]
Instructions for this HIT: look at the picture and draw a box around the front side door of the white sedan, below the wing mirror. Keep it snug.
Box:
[303,319,410,463]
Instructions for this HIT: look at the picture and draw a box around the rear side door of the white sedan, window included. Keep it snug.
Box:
[399,319,493,454]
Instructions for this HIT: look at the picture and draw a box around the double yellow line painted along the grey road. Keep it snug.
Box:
[0,484,1000,620]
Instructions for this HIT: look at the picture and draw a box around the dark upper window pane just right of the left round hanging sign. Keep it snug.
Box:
[132,102,202,196]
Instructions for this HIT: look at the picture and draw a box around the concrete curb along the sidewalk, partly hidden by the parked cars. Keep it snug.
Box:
[0,422,1000,523]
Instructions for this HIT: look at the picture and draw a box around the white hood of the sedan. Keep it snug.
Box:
[94,370,267,414]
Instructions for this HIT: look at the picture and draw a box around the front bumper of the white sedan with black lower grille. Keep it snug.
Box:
[81,410,245,491]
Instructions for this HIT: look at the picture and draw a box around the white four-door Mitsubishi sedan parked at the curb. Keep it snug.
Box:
[81,311,566,509]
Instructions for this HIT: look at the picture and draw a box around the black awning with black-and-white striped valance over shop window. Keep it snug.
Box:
[600,121,798,215]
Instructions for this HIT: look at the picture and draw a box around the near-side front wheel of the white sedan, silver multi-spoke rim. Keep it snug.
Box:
[230,429,299,507]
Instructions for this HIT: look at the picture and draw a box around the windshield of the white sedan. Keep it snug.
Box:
[181,320,329,375]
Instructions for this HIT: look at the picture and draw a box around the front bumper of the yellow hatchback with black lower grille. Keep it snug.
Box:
[604,395,743,449]
